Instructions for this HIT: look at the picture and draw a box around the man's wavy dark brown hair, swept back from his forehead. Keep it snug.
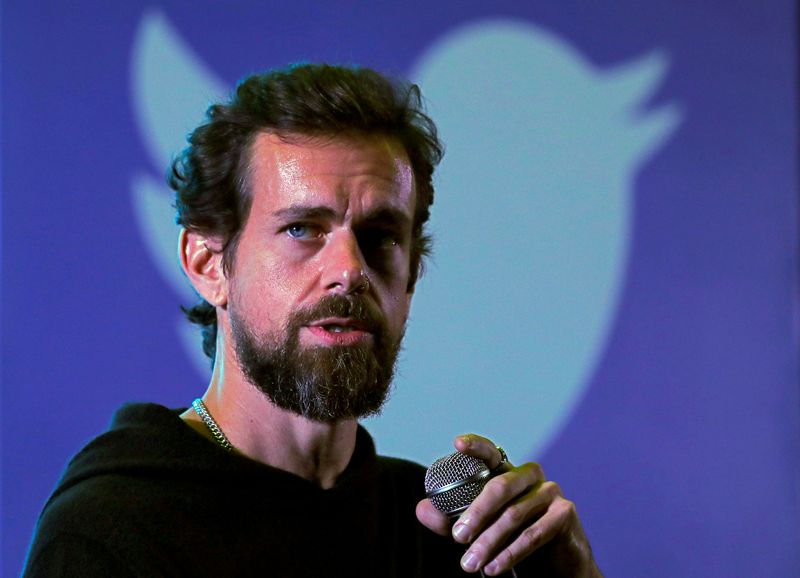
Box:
[168,64,443,361]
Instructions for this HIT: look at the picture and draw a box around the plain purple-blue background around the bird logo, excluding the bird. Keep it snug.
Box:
[0,0,800,577]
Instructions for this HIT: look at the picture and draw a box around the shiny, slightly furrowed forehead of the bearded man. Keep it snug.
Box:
[248,132,415,212]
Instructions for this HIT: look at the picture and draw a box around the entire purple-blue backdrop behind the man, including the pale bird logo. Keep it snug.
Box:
[0,0,800,578]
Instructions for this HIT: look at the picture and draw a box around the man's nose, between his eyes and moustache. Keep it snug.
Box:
[322,231,369,295]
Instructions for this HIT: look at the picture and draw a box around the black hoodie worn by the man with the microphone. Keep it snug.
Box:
[24,404,464,578]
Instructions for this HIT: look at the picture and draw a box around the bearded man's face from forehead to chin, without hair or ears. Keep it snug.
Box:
[222,133,416,422]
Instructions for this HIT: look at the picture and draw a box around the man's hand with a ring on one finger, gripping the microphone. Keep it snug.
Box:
[417,434,602,578]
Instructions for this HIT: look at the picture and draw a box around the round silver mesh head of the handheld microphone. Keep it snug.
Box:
[425,452,489,516]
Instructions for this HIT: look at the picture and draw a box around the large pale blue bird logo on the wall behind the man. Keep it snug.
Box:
[132,12,681,461]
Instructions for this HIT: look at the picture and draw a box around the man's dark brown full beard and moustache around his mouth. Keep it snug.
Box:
[230,295,402,423]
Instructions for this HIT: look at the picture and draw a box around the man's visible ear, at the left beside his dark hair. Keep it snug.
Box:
[178,229,228,307]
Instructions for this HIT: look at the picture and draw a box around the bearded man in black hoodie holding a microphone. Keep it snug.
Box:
[26,65,600,577]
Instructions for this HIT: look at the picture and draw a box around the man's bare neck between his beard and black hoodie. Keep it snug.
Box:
[181,362,358,489]
